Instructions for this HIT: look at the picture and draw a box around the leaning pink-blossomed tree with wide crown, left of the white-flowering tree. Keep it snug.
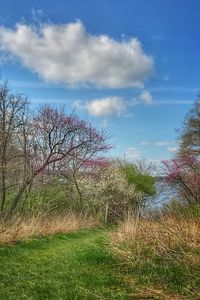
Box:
[7,105,110,217]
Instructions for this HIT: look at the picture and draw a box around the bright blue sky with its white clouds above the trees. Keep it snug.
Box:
[0,0,200,161]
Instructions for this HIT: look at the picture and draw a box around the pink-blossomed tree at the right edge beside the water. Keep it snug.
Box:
[162,154,200,204]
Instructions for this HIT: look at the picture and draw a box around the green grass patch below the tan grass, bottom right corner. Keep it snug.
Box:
[127,253,200,300]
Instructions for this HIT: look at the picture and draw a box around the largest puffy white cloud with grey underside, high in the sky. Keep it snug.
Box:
[0,21,154,86]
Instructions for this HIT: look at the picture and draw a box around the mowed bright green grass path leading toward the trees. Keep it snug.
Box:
[0,229,132,300]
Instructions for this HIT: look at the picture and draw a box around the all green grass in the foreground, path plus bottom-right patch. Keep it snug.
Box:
[0,229,200,300]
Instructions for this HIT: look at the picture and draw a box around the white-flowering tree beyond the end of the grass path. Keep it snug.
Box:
[76,165,142,222]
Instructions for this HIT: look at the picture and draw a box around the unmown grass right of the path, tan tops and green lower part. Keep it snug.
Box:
[110,217,200,299]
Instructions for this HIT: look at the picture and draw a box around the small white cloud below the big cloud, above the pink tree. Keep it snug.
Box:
[75,97,126,117]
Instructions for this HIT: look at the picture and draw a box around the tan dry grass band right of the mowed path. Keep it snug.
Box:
[111,217,200,260]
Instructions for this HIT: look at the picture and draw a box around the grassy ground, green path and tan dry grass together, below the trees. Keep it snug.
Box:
[0,217,200,300]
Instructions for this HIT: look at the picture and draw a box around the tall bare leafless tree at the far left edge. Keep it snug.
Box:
[0,83,27,214]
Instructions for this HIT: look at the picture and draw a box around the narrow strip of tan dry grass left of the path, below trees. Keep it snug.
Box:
[0,214,97,245]
